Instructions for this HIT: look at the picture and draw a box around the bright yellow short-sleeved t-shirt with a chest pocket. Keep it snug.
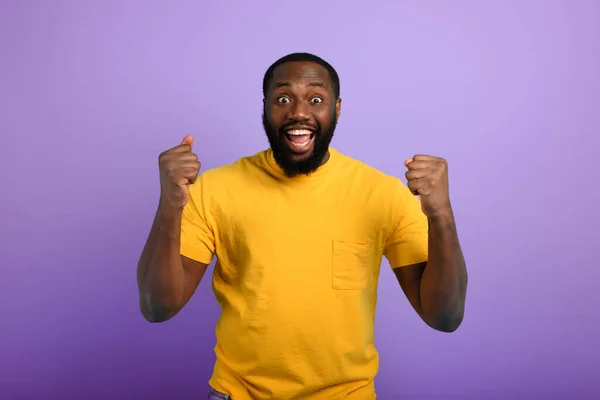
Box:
[181,149,428,400]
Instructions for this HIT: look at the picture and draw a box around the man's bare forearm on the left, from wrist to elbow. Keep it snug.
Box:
[137,205,185,321]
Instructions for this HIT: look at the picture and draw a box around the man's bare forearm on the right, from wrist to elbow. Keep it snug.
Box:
[420,210,467,332]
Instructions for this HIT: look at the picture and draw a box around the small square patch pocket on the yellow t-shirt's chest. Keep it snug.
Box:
[332,240,370,290]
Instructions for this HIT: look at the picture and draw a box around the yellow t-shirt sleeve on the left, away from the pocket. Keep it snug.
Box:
[180,175,215,264]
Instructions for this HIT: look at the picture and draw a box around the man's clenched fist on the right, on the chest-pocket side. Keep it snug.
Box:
[404,155,451,218]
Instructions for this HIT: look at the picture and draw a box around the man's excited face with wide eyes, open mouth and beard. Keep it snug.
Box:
[263,62,341,177]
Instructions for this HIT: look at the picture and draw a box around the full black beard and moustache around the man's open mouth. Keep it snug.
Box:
[262,108,337,178]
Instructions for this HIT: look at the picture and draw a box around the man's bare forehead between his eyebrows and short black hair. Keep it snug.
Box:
[269,61,332,90]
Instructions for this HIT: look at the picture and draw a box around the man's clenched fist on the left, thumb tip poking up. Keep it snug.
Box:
[158,135,200,209]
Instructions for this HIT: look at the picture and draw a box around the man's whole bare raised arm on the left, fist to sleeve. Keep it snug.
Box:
[137,136,207,322]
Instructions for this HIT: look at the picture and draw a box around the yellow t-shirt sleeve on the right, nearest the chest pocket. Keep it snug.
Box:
[383,180,429,268]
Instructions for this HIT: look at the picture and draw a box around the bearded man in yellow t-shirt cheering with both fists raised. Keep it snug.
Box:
[138,53,467,400]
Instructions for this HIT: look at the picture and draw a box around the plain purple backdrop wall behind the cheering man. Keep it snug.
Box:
[0,0,600,400]
